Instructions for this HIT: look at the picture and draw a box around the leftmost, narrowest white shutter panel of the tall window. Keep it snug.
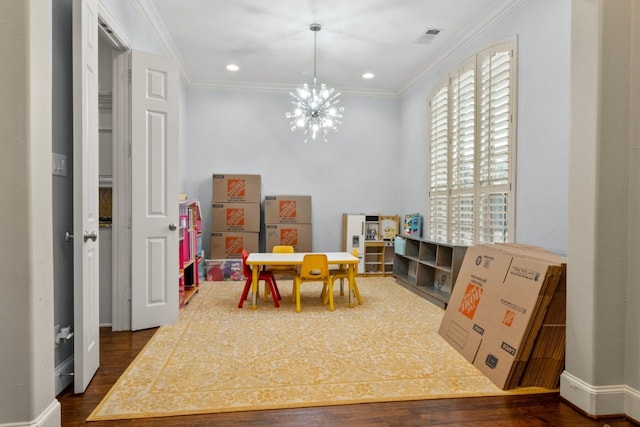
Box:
[429,84,449,241]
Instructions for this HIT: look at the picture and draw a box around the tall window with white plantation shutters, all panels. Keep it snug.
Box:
[428,43,516,245]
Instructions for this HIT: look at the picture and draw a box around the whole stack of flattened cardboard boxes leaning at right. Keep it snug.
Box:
[439,245,566,389]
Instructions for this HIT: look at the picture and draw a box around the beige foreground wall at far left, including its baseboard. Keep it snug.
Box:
[0,0,60,426]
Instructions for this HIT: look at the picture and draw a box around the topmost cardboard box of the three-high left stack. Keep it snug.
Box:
[211,174,262,203]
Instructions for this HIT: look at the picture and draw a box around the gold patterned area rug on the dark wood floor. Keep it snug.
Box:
[88,277,551,421]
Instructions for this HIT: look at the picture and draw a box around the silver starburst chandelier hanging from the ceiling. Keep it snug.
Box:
[286,24,344,143]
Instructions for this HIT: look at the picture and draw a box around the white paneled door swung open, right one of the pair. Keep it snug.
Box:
[131,52,179,331]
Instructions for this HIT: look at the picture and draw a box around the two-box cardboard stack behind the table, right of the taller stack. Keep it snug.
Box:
[264,195,311,252]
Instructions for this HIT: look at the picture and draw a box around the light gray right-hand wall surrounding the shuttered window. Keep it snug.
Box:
[398,0,571,254]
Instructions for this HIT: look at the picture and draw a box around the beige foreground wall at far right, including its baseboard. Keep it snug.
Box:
[561,0,640,420]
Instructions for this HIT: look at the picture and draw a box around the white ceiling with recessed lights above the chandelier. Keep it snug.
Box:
[137,0,522,95]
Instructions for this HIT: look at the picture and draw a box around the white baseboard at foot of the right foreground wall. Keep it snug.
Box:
[560,371,640,420]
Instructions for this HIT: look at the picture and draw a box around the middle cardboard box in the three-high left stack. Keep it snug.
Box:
[211,202,260,233]
